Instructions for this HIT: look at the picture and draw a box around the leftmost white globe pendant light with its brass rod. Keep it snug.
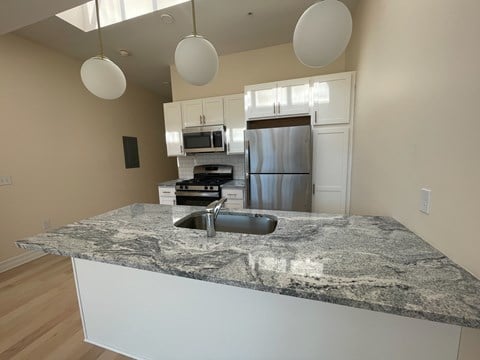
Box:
[80,0,127,100]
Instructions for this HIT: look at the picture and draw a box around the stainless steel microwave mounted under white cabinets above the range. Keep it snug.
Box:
[183,125,225,154]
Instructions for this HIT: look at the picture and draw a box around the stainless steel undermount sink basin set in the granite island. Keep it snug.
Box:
[174,211,278,235]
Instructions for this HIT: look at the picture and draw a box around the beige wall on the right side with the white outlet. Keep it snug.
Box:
[346,0,480,354]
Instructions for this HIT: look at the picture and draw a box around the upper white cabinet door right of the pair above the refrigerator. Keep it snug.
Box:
[311,72,354,126]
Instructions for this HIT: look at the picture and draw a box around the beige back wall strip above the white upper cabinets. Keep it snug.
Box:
[170,43,345,101]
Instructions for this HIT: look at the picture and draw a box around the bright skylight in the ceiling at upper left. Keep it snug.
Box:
[57,0,189,32]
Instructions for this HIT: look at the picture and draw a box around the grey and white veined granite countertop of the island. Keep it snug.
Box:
[17,204,480,328]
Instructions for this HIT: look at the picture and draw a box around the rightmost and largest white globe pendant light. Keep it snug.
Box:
[293,0,352,67]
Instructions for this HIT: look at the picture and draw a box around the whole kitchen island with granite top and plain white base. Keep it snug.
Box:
[17,204,480,359]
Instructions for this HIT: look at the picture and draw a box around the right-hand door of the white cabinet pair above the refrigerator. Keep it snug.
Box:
[277,78,310,116]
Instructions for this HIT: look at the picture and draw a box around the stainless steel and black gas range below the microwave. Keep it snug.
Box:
[175,165,233,206]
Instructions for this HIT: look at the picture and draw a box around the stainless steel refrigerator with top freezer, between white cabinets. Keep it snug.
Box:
[245,125,312,211]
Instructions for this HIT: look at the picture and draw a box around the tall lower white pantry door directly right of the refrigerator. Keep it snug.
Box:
[312,126,349,214]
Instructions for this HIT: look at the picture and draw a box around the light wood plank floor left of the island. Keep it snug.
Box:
[0,255,129,360]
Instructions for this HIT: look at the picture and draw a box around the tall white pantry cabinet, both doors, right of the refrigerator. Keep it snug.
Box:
[311,72,355,214]
